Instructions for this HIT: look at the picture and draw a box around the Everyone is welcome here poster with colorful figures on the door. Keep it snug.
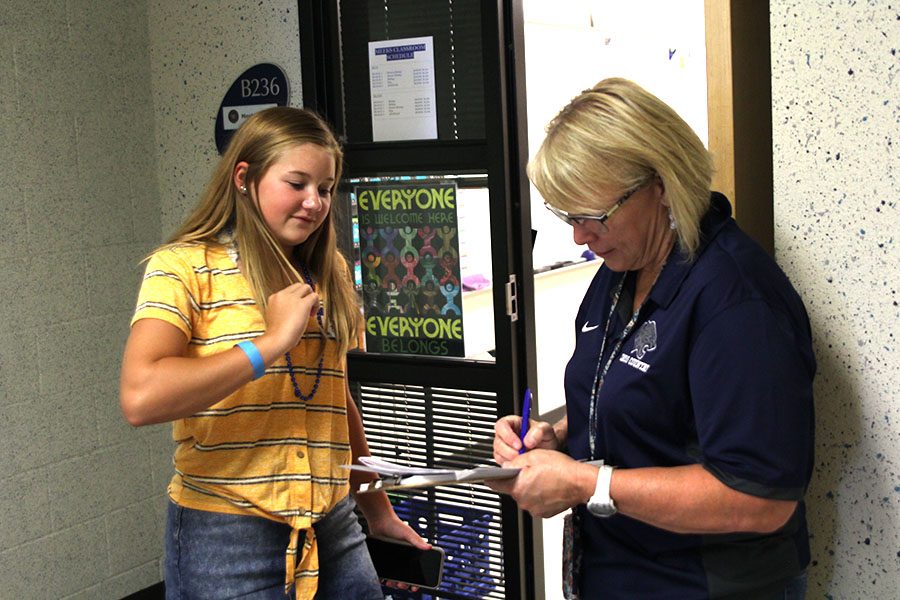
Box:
[354,182,465,356]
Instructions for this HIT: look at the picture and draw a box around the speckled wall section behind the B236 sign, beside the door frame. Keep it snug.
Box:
[148,0,302,235]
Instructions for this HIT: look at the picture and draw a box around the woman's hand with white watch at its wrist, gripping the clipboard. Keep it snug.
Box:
[487,448,597,518]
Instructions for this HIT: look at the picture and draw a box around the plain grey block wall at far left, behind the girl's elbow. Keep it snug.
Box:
[0,0,171,599]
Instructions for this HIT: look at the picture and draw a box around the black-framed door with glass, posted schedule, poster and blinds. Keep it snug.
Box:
[299,0,536,599]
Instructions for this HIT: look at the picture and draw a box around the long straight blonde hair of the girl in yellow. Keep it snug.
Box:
[159,107,360,356]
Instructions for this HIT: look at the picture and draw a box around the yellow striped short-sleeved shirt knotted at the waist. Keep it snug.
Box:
[132,244,351,599]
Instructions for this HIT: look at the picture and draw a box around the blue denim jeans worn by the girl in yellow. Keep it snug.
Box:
[166,496,384,600]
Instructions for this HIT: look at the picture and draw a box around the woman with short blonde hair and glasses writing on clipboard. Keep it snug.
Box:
[493,79,815,600]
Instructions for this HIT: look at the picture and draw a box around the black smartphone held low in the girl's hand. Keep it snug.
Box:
[366,535,444,589]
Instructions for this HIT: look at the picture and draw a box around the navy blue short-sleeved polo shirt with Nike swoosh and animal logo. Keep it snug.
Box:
[565,193,815,599]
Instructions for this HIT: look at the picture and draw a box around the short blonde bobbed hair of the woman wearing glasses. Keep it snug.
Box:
[528,78,713,260]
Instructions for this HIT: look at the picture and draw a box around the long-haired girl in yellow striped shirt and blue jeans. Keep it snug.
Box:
[120,107,428,599]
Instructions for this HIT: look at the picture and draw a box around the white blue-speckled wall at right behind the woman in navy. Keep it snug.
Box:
[771,0,900,598]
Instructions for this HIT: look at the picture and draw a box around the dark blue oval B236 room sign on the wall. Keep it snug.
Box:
[216,63,290,154]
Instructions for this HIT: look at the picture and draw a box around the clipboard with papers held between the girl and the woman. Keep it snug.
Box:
[344,456,519,493]
